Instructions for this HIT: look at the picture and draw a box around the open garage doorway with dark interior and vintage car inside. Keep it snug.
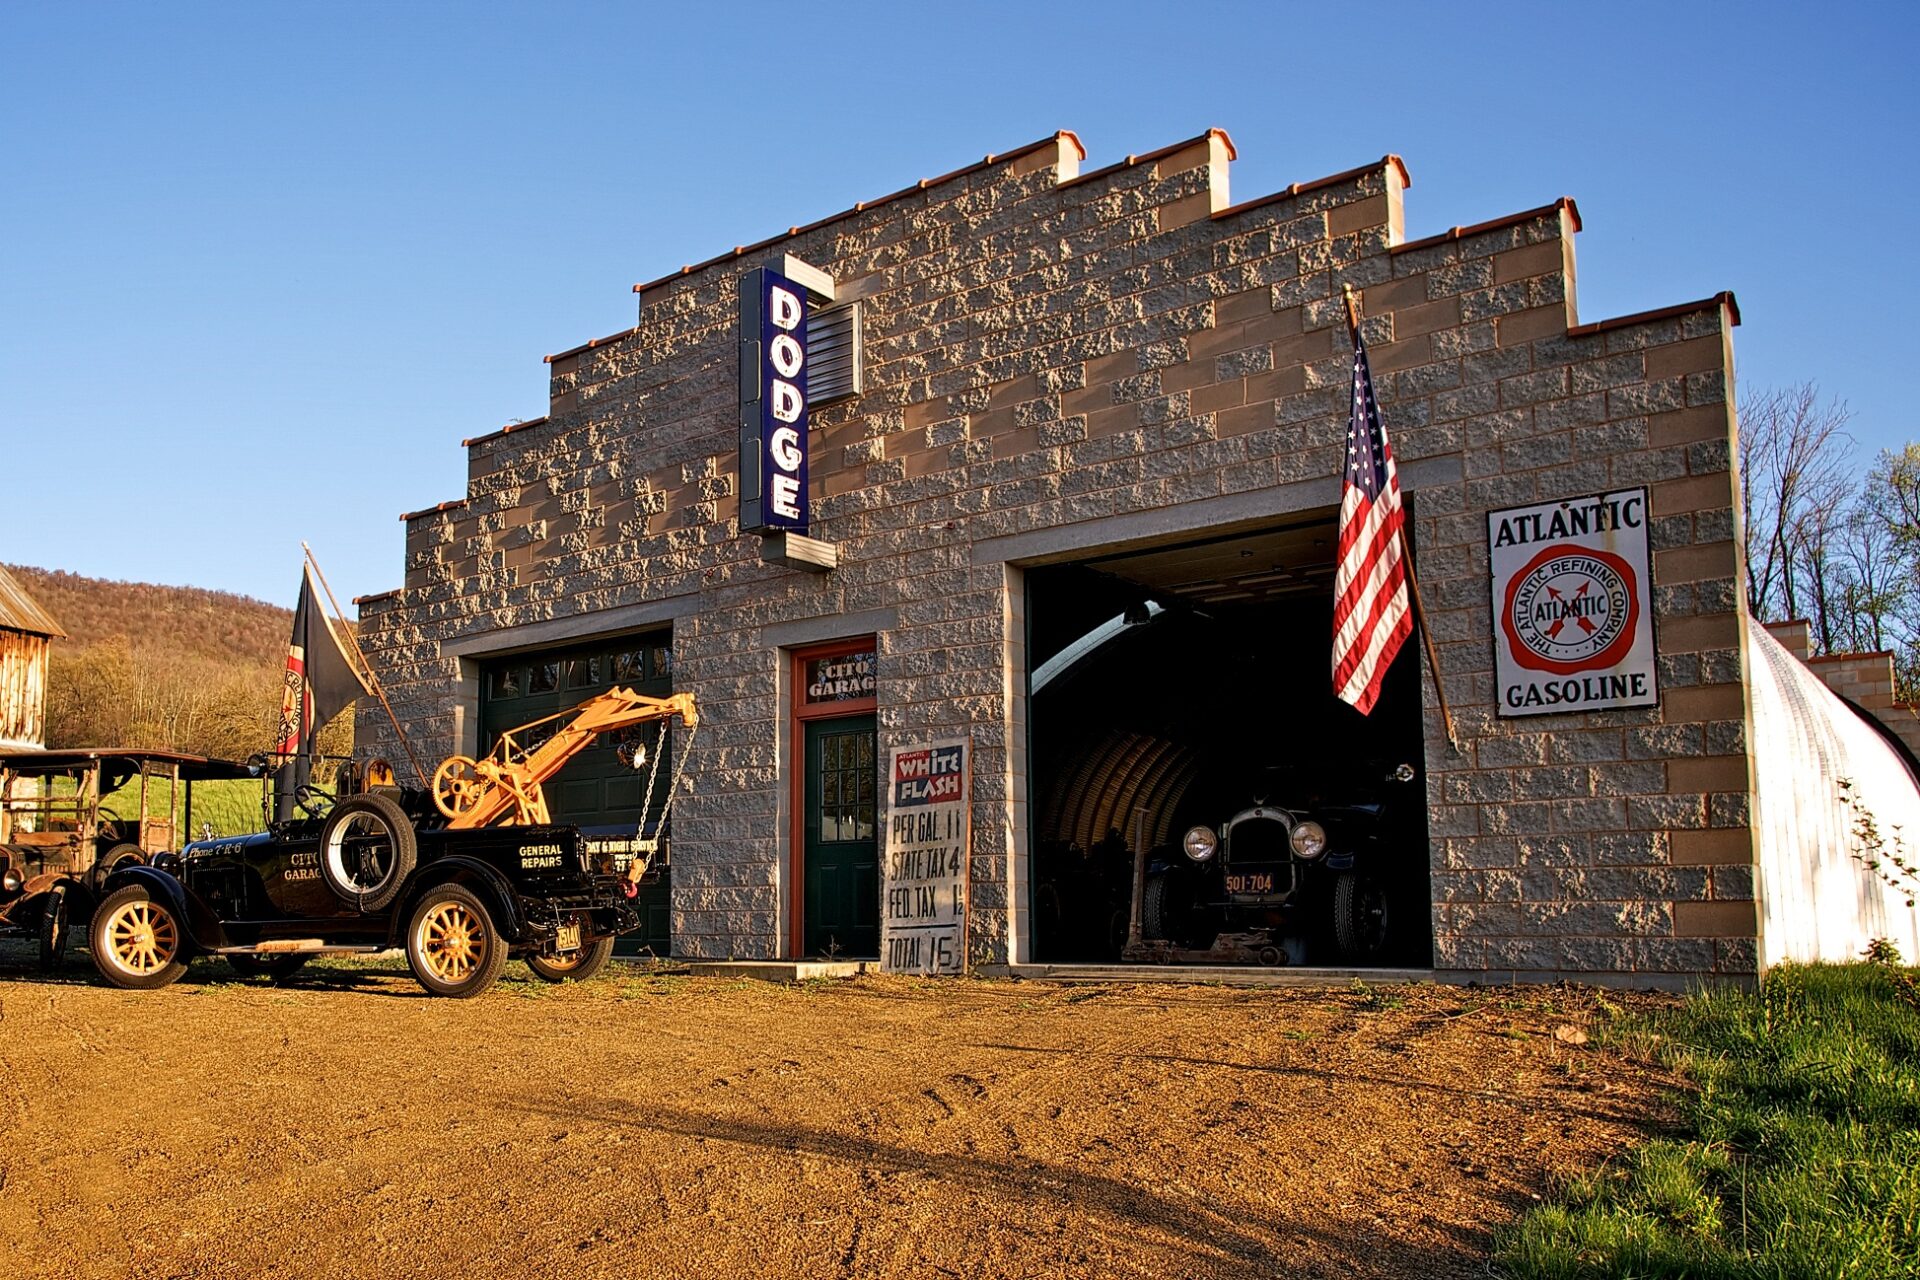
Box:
[1025,510,1432,967]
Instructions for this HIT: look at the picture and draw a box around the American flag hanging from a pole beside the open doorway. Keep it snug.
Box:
[1332,334,1413,716]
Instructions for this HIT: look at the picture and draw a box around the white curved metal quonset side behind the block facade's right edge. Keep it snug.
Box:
[1747,622,1920,965]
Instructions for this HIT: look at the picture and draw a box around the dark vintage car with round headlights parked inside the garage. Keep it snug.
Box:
[1129,764,1425,965]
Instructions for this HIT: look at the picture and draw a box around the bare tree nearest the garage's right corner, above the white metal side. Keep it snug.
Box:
[1740,382,1853,621]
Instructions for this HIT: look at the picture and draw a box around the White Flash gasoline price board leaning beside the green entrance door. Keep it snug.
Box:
[879,739,972,975]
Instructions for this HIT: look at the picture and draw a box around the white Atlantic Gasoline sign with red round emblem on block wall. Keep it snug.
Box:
[1486,489,1659,716]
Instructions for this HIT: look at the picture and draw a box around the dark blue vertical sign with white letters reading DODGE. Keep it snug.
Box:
[739,267,806,533]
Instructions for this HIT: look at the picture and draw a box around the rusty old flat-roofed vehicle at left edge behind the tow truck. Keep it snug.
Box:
[0,747,253,967]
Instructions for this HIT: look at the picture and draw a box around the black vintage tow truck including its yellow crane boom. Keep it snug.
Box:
[90,689,699,998]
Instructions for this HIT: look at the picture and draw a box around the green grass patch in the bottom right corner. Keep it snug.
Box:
[1496,963,1920,1280]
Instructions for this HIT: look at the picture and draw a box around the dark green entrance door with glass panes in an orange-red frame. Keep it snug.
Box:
[801,716,879,958]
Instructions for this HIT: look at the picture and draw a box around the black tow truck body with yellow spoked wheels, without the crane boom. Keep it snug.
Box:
[88,789,639,996]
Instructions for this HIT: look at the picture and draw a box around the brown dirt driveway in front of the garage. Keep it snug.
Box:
[0,952,1657,1280]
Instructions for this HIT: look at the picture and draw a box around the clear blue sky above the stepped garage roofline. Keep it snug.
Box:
[0,0,1920,604]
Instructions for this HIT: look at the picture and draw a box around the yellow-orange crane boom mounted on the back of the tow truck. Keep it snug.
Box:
[434,689,699,831]
